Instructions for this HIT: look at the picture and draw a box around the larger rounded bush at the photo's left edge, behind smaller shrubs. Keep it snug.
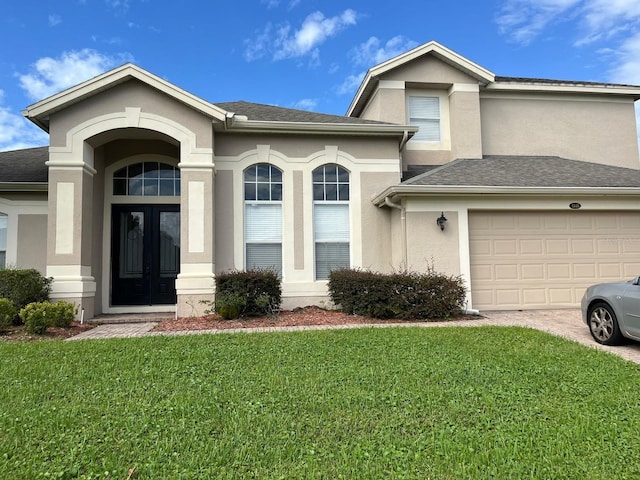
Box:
[0,268,53,320]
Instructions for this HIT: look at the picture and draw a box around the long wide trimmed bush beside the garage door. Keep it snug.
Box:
[329,269,466,319]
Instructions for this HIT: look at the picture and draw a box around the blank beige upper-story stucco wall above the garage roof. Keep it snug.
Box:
[480,93,640,168]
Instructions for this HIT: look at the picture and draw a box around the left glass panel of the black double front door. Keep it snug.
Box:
[119,212,144,278]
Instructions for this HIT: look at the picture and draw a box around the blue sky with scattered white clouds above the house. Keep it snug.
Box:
[0,0,640,150]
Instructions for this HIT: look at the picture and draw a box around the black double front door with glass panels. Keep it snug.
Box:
[111,205,180,305]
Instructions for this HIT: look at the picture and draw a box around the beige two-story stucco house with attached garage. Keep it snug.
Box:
[0,42,640,317]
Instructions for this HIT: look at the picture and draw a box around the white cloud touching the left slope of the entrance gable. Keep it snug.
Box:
[19,49,131,100]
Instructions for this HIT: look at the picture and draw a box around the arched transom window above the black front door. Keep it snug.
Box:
[113,162,180,197]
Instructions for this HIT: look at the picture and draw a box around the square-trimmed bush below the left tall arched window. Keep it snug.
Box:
[214,270,282,318]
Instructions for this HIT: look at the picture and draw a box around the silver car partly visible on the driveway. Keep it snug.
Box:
[581,277,640,345]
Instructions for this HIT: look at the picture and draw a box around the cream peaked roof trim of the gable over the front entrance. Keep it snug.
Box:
[22,63,226,131]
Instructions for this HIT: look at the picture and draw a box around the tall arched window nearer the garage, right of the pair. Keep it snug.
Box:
[313,165,351,280]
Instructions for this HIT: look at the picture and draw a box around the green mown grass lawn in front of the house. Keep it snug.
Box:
[0,327,640,480]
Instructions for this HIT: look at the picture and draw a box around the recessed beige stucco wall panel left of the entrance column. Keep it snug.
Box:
[16,215,47,273]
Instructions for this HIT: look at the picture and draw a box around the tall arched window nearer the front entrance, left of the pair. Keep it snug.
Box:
[244,163,282,276]
